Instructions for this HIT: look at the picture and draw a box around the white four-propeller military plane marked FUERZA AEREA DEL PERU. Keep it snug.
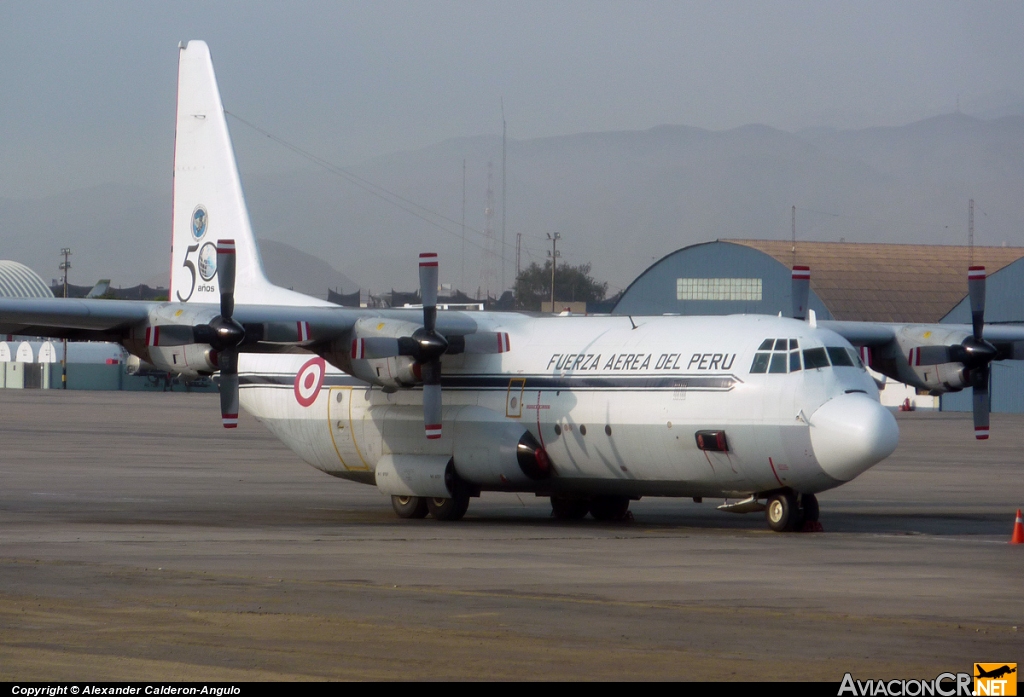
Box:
[0,41,1024,532]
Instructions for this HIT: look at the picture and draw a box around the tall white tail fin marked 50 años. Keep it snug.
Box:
[170,41,327,305]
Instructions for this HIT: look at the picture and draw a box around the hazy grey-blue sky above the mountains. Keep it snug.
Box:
[0,0,1024,199]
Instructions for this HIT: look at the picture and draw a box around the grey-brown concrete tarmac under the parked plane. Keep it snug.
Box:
[0,390,1024,682]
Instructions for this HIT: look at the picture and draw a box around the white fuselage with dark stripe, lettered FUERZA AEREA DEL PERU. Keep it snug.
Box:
[234,313,898,496]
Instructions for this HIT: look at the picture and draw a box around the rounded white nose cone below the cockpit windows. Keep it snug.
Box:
[810,393,899,482]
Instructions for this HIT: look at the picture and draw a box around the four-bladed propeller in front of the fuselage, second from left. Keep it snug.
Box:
[351,252,511,440]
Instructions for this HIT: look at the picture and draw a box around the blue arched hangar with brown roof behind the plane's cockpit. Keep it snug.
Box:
[611,239,1024,411]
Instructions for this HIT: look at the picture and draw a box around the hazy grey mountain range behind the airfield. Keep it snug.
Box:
[0,114,1024,296]
